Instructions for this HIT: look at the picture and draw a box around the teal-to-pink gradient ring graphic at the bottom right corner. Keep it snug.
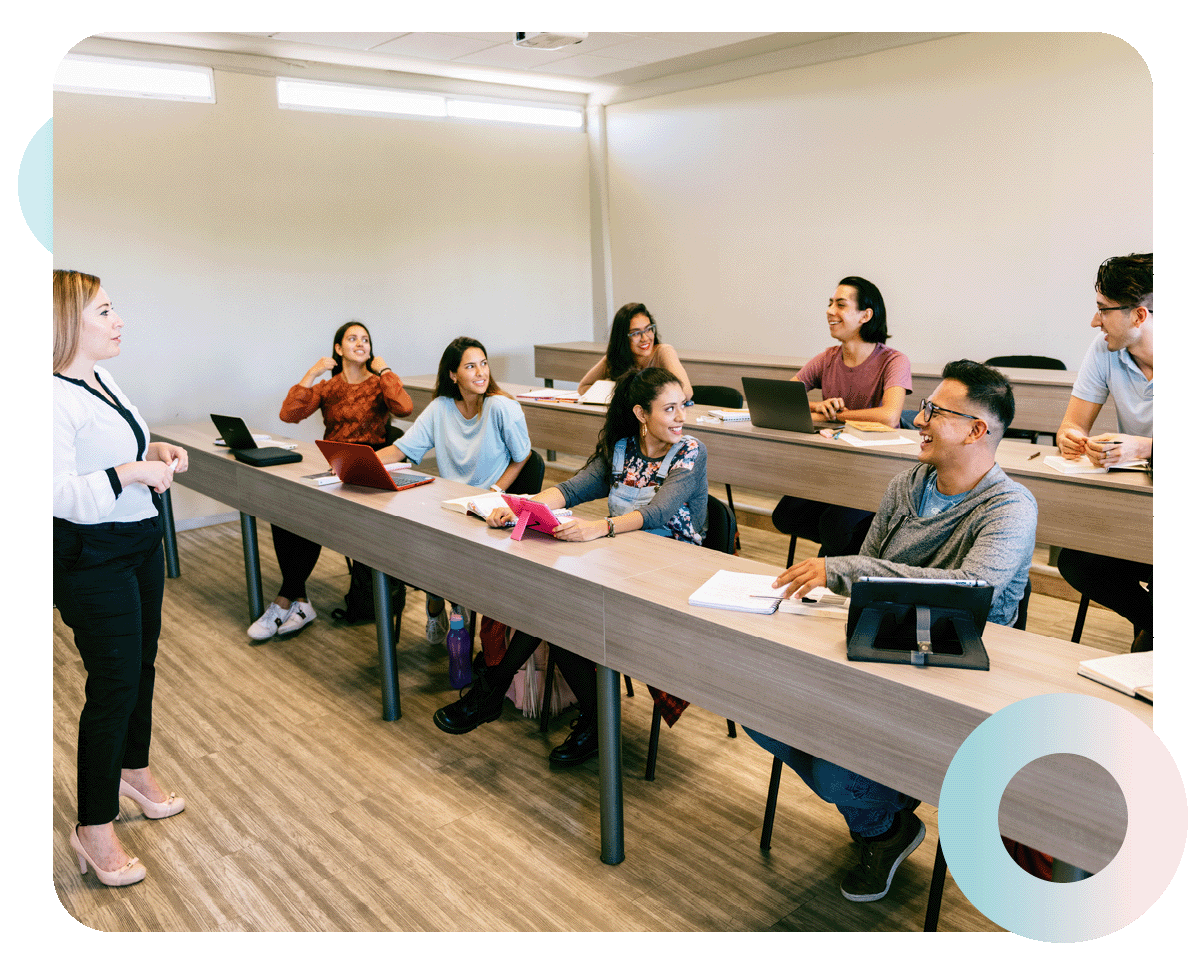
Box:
[937,694,1188,943]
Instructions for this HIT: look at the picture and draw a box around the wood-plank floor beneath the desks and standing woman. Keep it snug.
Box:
[53,464,1129,931]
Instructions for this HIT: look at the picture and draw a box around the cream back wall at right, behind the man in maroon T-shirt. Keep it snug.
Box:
[607,34,1152,370]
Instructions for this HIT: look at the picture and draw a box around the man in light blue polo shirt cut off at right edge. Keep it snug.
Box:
[1057,253,1154,650]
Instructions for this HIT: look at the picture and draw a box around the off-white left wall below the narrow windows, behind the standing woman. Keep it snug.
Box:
[54,66,592,521]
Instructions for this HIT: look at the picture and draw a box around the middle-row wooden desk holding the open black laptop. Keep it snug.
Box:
[403,376,1154,563]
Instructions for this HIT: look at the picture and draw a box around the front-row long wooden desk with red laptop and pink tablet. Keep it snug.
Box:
[154,424,1152,872]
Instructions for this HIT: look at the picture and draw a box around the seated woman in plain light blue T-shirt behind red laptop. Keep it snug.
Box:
[379,337,532,643]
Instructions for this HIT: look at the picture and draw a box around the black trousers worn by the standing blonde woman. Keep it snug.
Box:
[54,517,164,827]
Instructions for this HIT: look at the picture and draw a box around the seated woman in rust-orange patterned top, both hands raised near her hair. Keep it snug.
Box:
[246,320,413,643]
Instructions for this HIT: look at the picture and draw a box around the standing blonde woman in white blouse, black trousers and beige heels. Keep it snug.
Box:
[54,270,187,887]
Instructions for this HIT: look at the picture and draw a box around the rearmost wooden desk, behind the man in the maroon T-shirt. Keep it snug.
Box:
[533,341,1117,433]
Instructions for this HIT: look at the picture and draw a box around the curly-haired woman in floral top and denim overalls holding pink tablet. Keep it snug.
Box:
[433,367,708,767]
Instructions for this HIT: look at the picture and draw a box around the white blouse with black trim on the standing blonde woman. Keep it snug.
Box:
[54,367,158,523]
